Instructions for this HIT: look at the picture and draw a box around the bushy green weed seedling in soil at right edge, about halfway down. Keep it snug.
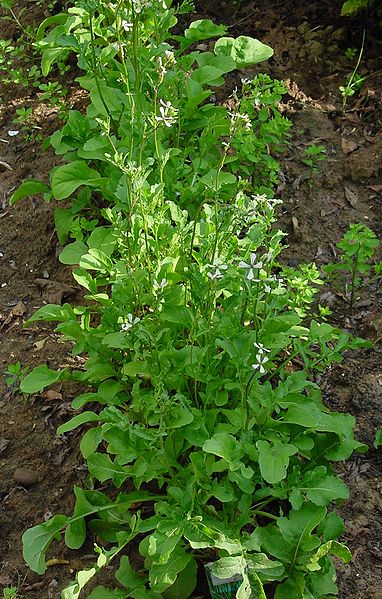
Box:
[325,223,382,309]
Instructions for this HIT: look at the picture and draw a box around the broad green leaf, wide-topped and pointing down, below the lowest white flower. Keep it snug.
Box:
[256,440,298,484]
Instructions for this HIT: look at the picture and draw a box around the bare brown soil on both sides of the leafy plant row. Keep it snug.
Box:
[0,0,382,599]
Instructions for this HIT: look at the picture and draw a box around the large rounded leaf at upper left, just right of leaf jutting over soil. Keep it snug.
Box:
[51,160,100,200]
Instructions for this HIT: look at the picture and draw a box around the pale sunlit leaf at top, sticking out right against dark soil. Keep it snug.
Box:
[214,35,273,69]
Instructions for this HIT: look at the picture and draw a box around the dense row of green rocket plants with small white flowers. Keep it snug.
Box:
[12,0,365,599]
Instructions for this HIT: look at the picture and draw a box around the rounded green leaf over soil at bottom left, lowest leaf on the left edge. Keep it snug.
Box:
[22,515,69,574]
